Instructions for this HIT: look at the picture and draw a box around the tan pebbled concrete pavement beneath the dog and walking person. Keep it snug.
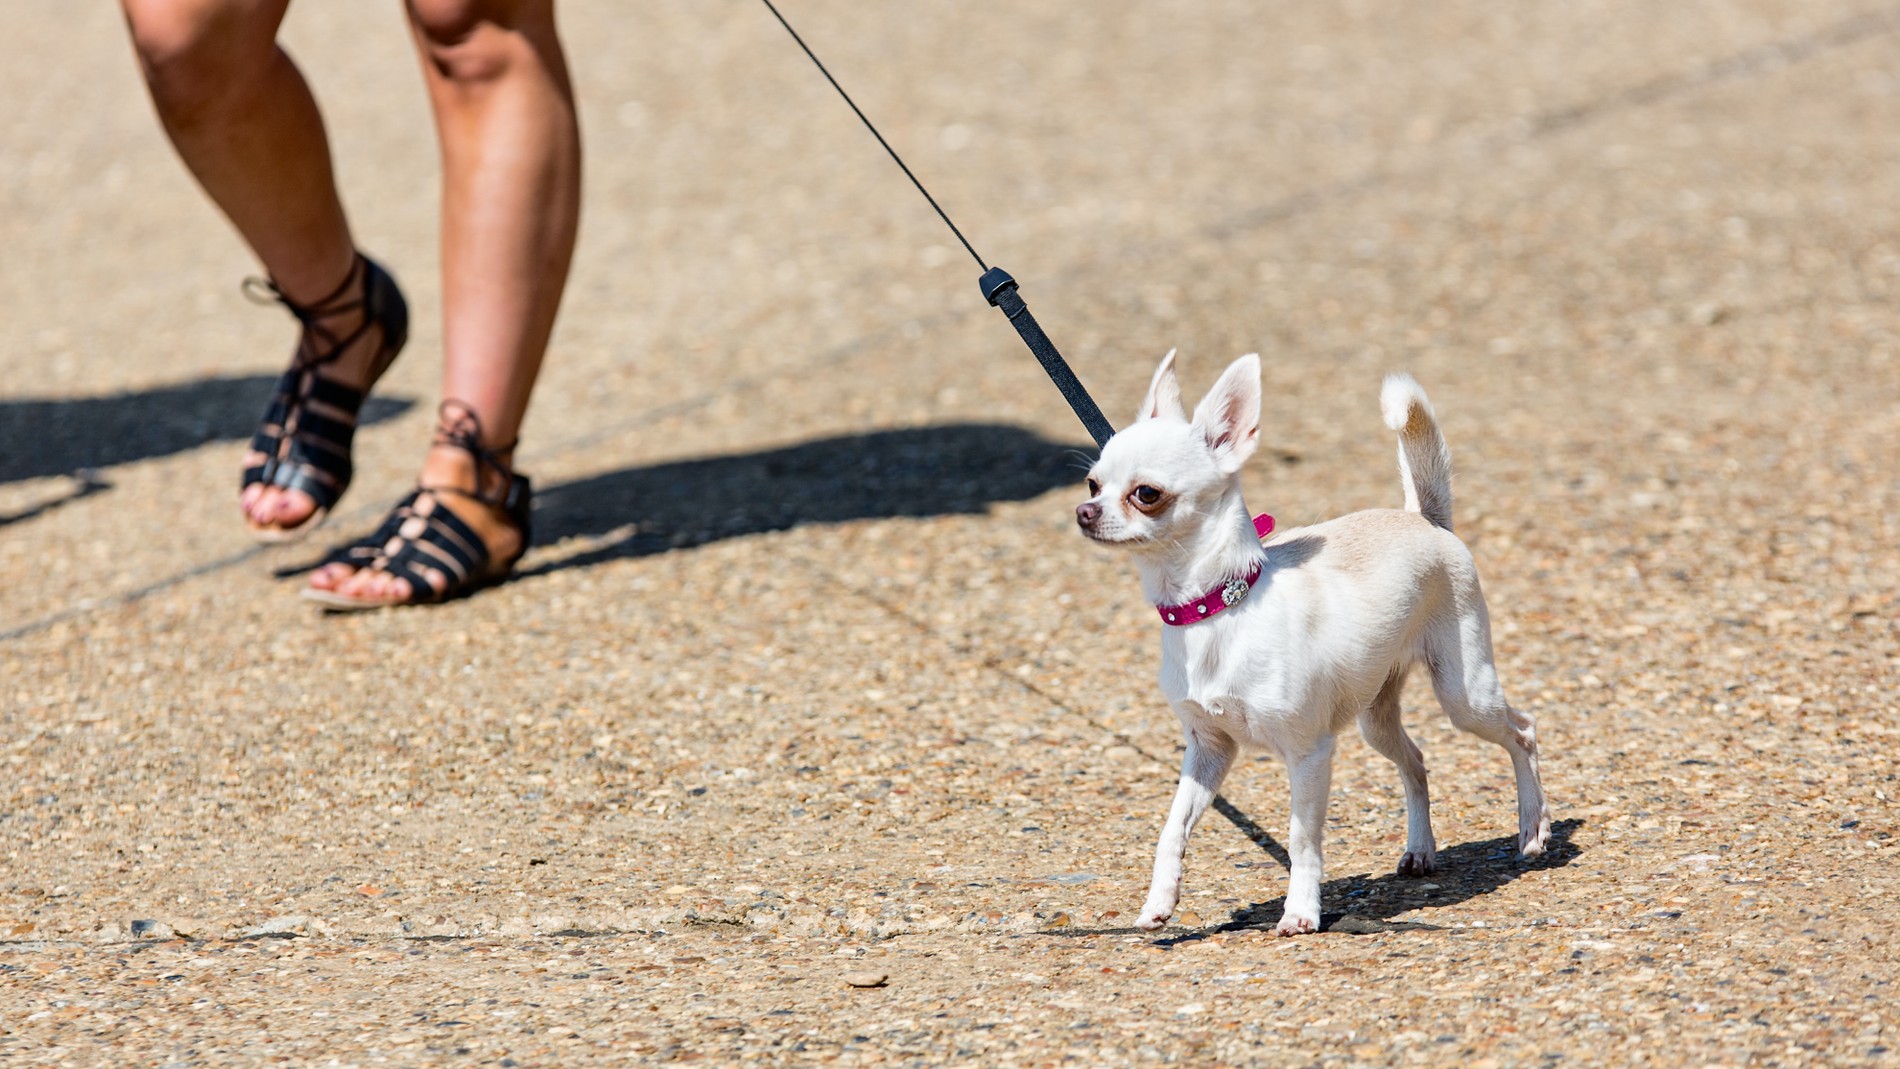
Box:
[0,0,1900,1065]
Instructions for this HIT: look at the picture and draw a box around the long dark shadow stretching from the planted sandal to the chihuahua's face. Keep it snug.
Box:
[515,423,1091,579]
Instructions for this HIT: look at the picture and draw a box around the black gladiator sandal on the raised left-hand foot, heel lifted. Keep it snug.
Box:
[241,253,409,541]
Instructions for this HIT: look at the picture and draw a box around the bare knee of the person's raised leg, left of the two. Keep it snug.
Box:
[124,0,268,120]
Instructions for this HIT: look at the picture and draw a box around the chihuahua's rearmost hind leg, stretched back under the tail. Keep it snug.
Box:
[1425,602,1550,856]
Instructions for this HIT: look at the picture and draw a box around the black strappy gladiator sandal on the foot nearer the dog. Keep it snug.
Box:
[304,401,534,611]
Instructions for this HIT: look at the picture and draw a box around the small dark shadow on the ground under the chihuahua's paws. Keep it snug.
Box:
[1049,818,1583,946]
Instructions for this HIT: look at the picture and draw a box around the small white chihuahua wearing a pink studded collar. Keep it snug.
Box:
[1075,351,1550,936]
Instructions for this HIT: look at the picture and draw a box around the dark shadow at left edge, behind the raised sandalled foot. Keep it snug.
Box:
[0,374,414,482]
